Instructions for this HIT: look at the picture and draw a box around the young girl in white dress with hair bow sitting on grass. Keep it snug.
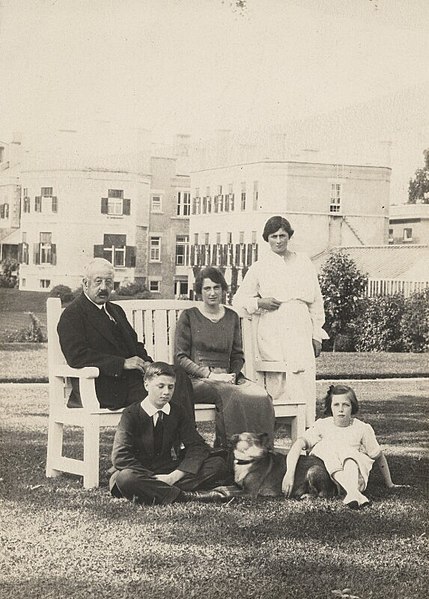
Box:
[282,385,399,510]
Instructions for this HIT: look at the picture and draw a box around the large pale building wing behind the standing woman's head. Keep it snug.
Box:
[190,160,391,290]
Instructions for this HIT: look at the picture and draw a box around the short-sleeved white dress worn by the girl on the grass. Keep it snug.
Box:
[304,416,381,491]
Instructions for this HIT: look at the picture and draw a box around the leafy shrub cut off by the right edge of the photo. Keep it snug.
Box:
[401,289,429,352]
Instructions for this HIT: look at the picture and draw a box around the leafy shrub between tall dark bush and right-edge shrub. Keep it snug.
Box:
[353,294,405,352]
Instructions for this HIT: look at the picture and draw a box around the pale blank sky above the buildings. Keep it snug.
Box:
[0,0,429,202]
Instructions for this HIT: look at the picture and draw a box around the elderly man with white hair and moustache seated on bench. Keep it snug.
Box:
[58,258,194,420]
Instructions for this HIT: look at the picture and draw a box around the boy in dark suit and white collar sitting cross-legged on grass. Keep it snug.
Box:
[110,362,230,505]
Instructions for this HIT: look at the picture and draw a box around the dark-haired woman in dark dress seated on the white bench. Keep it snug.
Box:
[175,266,274,448]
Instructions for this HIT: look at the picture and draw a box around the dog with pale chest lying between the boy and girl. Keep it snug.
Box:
[231,433,336,499]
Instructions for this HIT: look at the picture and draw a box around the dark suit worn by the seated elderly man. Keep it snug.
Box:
[58,293,153,410]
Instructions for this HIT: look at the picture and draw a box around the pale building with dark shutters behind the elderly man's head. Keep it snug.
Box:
[19,169,150,290]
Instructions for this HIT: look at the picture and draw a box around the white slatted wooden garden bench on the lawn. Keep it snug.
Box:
[46,298,306,489]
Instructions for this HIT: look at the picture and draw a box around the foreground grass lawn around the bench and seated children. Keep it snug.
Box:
[0,380,429,599]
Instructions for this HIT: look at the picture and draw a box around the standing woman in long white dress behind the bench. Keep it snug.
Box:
[233,216,328,426]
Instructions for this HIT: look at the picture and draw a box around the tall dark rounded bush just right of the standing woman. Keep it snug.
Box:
[319,250,368,350]
